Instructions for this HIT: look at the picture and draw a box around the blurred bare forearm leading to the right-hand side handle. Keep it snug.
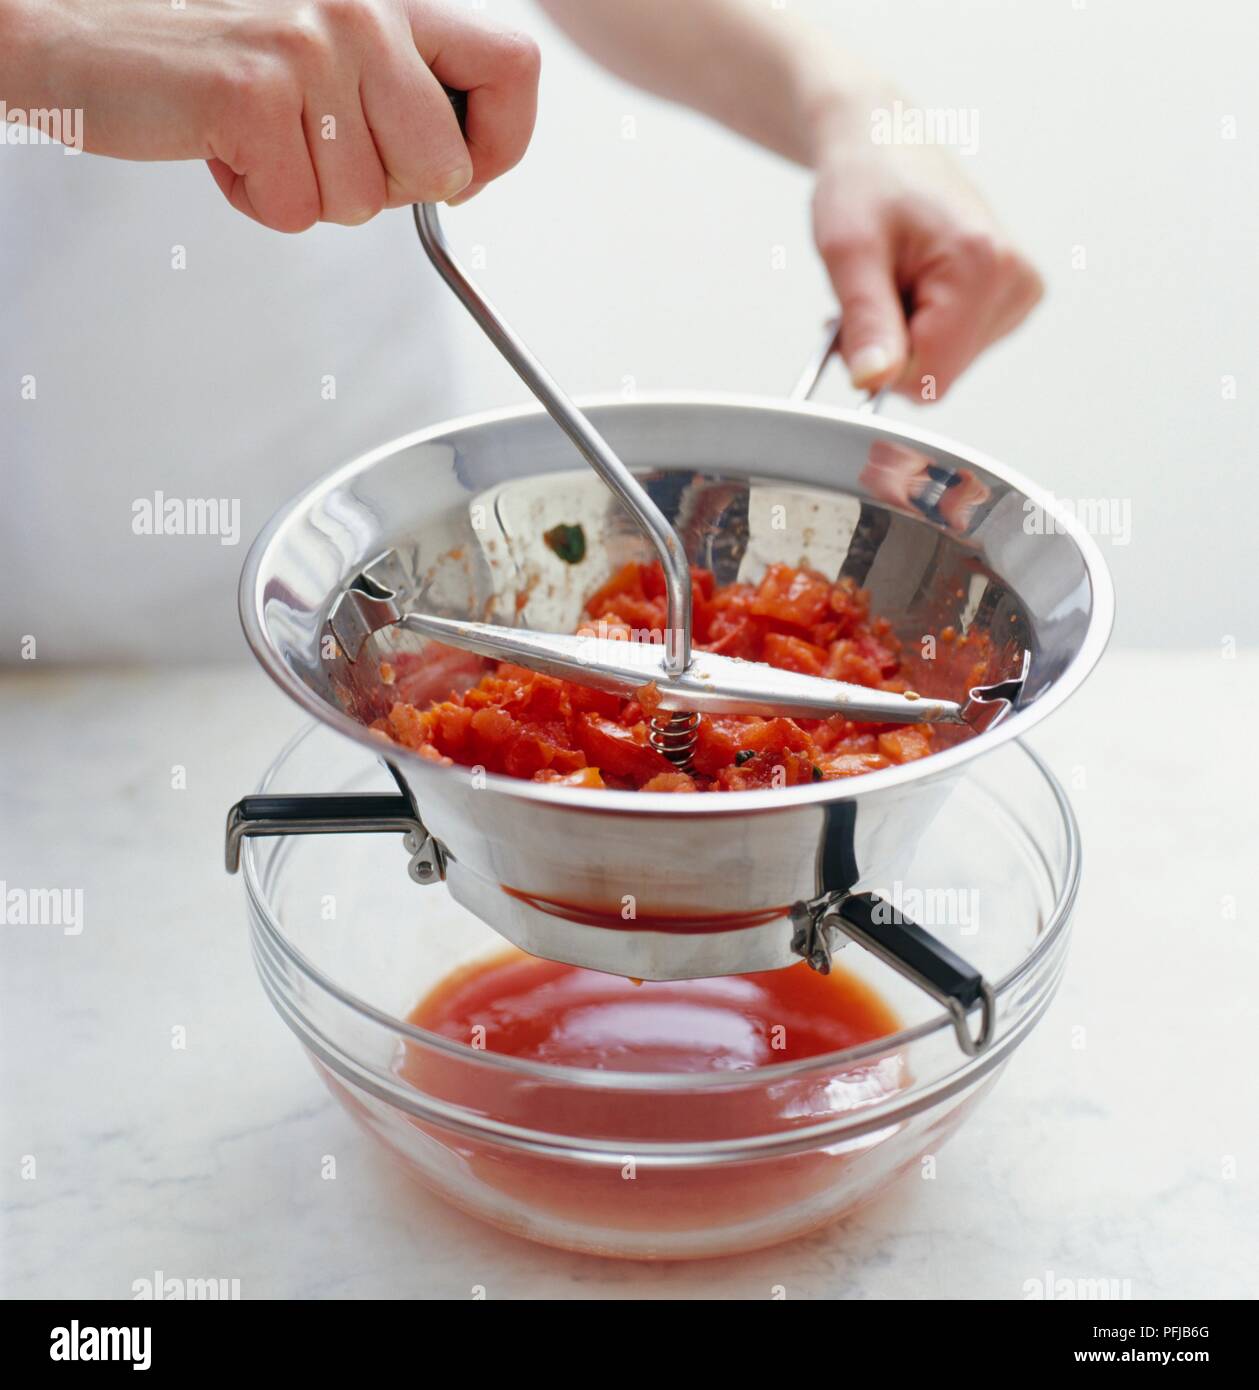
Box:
[539,0,891,165]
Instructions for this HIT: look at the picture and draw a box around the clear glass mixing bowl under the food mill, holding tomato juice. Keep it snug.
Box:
[243,727,1080,1259]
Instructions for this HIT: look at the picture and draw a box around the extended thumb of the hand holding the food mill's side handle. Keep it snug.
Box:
[823,232,909,391]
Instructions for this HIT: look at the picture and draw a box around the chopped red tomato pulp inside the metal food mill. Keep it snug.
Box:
[372,564,931,791]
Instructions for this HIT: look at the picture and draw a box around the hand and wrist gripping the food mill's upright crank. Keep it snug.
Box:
[18,0,539,232]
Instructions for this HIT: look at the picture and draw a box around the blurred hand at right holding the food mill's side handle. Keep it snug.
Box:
[813,109,1042,400]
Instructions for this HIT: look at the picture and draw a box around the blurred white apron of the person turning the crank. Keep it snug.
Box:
[0,145,471,664]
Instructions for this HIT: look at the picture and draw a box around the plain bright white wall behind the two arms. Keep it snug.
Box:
[447,0,1259,645]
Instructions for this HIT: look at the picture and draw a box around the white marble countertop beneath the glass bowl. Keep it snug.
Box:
[0,652,1259,1298]
